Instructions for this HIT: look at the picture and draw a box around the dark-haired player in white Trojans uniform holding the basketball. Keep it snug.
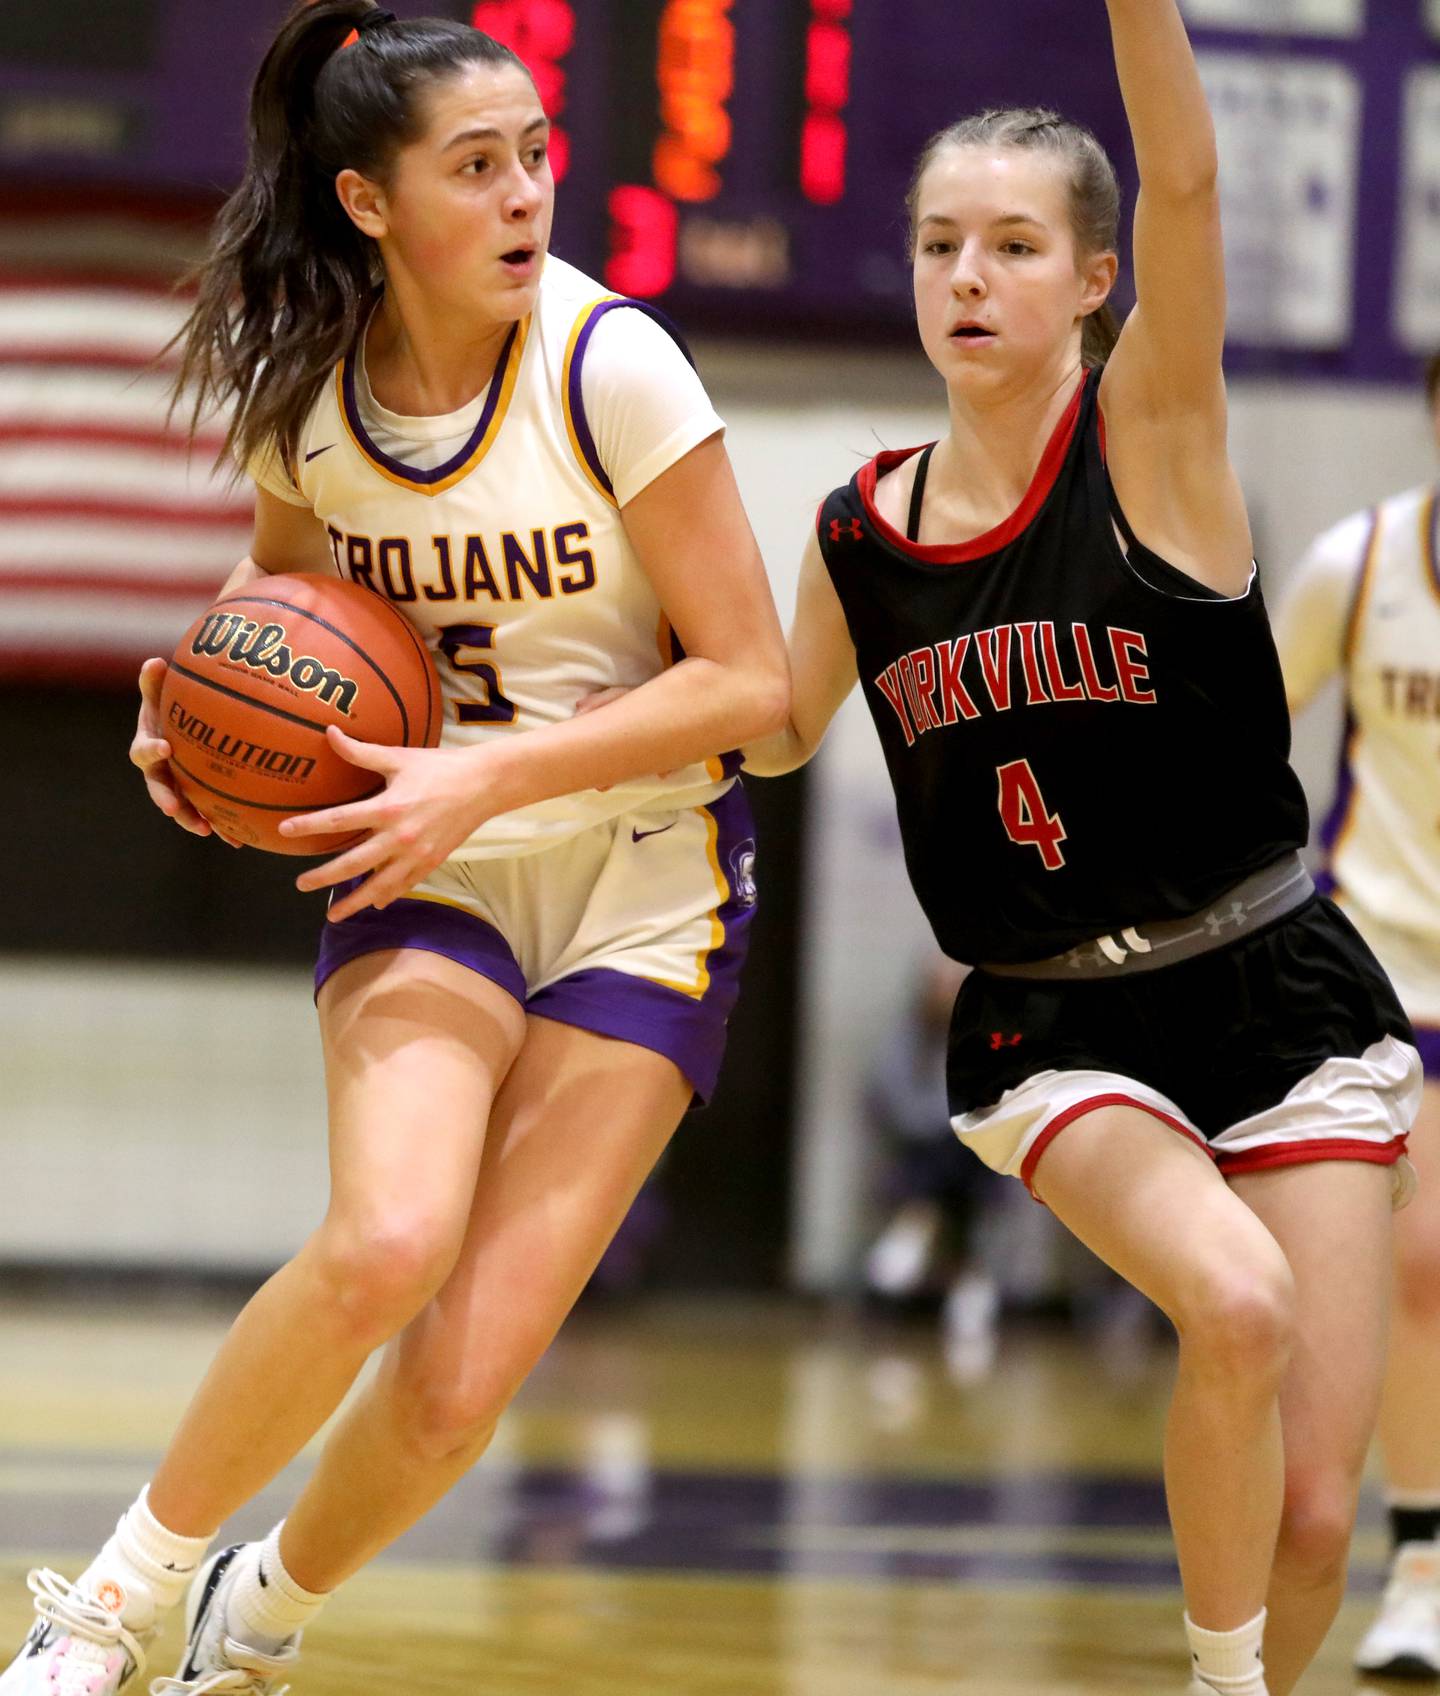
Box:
[0,0,789,1696]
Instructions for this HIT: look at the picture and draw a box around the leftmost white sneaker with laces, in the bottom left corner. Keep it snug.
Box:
[0,1567,154,1696]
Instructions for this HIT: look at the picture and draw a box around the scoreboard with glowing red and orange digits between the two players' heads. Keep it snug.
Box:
[446,0,1125,334]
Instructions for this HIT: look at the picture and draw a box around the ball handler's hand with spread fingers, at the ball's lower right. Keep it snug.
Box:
[280,726,490,923]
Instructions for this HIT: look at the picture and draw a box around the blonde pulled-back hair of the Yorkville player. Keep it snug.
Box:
[906,107,1119,366]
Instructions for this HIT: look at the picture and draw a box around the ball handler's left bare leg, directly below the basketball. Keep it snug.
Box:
[149,950,524,1535]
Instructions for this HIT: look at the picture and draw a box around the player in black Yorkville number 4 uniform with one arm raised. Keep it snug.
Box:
[746,0,1420,1696]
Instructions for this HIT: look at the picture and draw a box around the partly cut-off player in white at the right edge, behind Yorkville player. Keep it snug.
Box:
[1275,354,1440,1677]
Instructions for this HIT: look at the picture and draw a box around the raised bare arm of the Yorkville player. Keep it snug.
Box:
[1101,0,1253,595]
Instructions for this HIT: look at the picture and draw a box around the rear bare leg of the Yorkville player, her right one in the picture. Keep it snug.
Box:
[1231,1160,1393,1696]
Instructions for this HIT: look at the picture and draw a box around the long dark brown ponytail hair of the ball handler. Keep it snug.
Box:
[175,0,524,478]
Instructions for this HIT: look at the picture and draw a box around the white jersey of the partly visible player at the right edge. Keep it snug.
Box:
[1316,488,1440,942]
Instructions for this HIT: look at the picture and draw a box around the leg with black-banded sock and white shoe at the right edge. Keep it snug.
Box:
[1355,1082,1440,1676]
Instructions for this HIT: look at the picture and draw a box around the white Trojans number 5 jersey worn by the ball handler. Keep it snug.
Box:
[292,258,734,860]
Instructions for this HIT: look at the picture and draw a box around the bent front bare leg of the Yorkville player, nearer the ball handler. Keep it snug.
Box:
[1035,1107,1294,1691]
